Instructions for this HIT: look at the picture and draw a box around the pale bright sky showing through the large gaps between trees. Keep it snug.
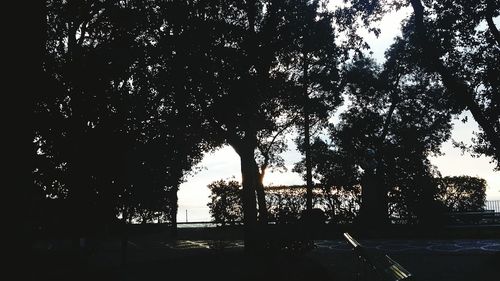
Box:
[177,6,500,222]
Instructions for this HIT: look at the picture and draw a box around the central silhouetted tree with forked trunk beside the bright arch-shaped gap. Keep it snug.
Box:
[168,1,344,248]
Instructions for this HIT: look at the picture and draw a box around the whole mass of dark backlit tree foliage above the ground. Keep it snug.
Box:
[38,0,500,245]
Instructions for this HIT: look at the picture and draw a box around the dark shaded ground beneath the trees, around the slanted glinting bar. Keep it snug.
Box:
[25,225,500,281]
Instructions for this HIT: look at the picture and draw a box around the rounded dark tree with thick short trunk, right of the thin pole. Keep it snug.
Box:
[300,32,453,225]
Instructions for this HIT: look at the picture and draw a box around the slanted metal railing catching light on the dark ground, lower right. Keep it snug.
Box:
[344,232,414,281]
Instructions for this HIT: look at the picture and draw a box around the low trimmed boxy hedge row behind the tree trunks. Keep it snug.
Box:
[208,176,486,225]
